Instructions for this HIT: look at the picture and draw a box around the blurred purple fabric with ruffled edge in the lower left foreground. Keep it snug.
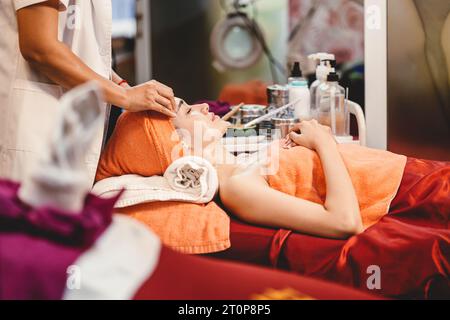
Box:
[0,180,120,300]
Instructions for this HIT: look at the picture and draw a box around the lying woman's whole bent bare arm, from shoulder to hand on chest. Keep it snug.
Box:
[220,122,363,238]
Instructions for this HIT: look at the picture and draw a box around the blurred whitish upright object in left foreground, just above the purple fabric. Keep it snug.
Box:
[18,82,105,212]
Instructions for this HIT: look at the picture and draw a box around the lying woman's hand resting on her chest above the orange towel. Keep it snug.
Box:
[282,120,336,150]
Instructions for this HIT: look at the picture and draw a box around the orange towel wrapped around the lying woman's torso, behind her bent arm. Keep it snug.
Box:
[268,145,407,228]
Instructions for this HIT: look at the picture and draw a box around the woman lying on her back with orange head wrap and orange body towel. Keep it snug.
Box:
[96,101,406,238]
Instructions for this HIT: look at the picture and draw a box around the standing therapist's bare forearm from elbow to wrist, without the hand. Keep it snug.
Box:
[26,41,127,107]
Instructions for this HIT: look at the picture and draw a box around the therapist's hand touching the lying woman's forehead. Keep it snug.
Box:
[124,80,176,117]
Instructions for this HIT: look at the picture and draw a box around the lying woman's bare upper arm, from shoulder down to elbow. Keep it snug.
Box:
[220,176,361,239]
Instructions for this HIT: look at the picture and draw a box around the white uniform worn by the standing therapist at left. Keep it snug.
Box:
[0,0,112,182]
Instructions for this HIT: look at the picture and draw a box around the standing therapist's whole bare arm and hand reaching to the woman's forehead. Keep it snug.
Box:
[17,0,175,116]
